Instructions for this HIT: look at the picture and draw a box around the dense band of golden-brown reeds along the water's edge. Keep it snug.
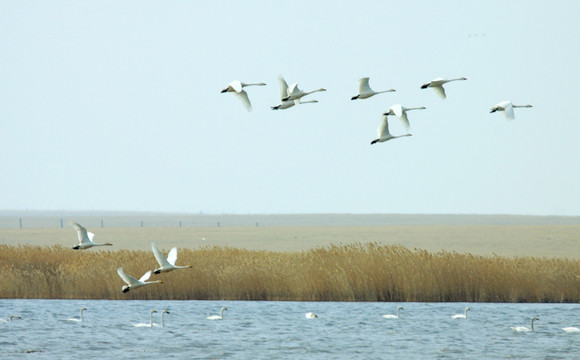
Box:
[0,243,580,303]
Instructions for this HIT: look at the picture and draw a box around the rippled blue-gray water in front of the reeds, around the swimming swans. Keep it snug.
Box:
[0,300,580,359]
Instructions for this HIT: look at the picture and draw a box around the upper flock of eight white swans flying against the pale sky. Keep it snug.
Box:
[221,76,532,145]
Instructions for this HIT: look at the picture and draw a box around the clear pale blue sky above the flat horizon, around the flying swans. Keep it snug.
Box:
[0,0,580,215]
